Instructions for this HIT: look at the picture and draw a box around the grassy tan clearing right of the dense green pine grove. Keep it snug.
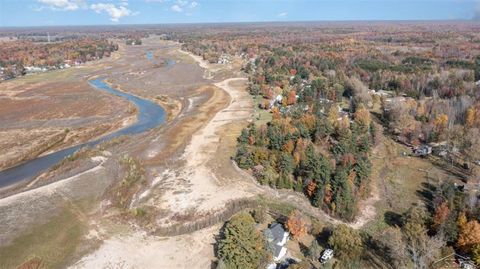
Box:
[365,132,463,233]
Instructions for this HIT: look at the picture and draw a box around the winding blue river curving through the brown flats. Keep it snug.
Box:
[0,76,165,189]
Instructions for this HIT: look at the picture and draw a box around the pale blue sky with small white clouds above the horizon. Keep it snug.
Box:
[0,0,480,27]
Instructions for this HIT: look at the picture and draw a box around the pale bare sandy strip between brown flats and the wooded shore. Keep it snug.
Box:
[71,49,258,268]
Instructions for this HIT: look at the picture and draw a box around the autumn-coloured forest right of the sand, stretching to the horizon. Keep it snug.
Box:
[172,23,480,268]
